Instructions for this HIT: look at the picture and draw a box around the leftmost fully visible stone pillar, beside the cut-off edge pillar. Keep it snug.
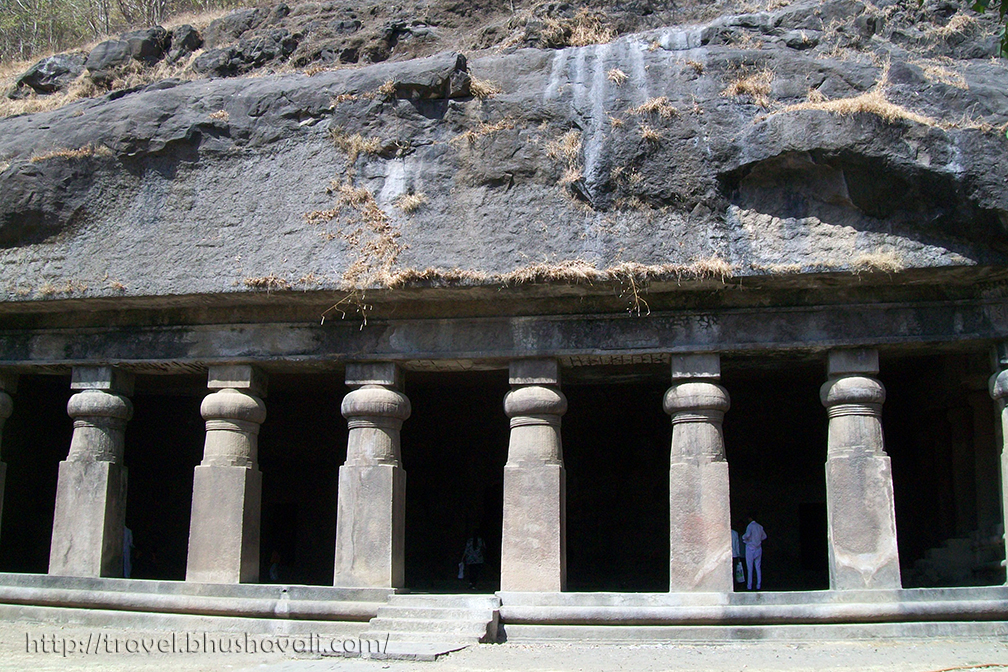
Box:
[49,367,133,576]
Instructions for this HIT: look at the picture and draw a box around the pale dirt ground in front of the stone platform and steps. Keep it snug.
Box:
[0,621,1008,672]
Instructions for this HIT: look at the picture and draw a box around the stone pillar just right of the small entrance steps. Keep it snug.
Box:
[501,359,566,592]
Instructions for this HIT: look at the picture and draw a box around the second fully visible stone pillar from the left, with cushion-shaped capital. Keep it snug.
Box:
[185,365,267,583]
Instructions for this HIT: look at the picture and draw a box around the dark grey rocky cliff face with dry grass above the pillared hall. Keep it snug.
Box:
[0,0,1008,301]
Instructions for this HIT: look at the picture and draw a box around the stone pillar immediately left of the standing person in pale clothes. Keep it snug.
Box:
[664,355,733,592]
